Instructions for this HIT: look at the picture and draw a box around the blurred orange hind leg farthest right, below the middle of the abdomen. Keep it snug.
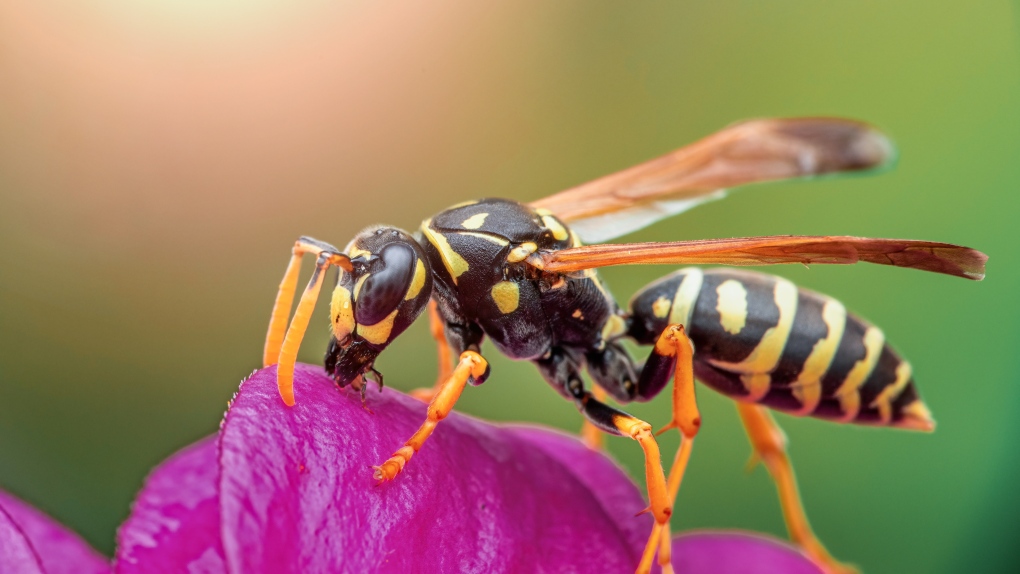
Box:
[736,403,857,574]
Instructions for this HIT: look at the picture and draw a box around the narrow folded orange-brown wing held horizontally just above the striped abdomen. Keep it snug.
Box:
[534,236,988,280]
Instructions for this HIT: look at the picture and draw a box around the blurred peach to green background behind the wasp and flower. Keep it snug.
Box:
[0,0,1020,573]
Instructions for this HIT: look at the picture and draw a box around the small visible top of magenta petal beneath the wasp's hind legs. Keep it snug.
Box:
[672,530,823,574]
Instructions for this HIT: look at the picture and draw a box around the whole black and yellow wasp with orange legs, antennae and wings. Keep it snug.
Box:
[263,117,987,572]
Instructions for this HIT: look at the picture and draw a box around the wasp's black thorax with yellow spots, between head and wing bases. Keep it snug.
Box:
[419,199,615,360]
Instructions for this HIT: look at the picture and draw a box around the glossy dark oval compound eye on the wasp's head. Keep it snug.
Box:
[354,243,414,325]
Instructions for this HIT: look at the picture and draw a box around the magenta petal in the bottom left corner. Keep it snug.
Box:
[0,491,110,574]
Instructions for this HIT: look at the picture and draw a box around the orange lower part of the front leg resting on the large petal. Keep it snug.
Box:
[372,351,489,482]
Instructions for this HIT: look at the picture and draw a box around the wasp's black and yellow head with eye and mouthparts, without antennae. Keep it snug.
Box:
[326,227,432,384]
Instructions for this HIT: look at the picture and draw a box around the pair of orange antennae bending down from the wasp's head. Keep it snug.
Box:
[262,238,351,407]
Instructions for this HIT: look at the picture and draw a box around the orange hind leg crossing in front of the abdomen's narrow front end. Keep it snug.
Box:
[638,325,701,573]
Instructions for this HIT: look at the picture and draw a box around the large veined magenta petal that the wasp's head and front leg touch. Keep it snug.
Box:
[220,365,649,572]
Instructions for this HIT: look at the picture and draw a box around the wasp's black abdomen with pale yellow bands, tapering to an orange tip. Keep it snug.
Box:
[629,267,933,430]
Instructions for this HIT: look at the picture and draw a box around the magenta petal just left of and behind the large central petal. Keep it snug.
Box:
[114,438,226,574]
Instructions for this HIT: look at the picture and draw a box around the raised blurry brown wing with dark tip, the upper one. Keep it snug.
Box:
[531,117,894,243]
